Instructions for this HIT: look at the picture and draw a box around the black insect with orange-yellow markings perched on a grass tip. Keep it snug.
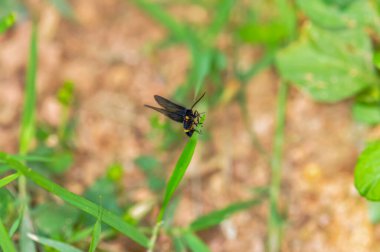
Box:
[144,93,205,137]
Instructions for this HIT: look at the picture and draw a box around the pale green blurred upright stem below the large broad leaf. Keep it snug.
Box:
[268,82,288,252]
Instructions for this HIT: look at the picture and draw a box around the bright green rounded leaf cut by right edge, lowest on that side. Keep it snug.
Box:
[355,142,380,201]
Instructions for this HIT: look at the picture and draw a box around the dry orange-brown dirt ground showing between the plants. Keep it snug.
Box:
[0,0,380,252]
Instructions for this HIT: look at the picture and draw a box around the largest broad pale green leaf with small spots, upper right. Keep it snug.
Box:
[277,25,377,102]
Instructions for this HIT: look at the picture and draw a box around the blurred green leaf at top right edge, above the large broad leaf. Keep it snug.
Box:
[297,0,379,31]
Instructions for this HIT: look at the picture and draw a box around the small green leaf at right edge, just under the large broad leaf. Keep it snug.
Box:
[352,102,380,125]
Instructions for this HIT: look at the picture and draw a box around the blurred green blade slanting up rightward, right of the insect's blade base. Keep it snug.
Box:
[189,199,262,232]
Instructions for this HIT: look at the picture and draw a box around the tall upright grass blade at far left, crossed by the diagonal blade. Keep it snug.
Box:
[18,24,38,252]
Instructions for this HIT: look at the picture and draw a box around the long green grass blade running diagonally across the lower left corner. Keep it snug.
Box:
[0,152,149,247]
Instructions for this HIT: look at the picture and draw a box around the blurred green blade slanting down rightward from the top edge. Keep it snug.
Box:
[134,0,189,40]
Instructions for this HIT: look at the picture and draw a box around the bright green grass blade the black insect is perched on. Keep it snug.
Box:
[157,134,198,222]
